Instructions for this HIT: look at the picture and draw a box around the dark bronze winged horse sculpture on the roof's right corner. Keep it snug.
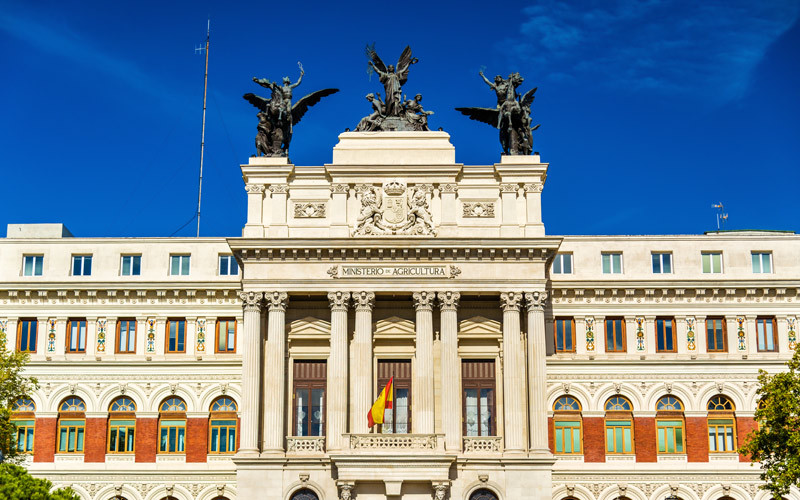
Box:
[456,71,539,155]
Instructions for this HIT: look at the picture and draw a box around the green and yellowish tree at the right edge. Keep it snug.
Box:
[739,349,800,498]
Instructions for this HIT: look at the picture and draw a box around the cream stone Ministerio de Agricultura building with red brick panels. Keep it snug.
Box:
[0,132,800,500]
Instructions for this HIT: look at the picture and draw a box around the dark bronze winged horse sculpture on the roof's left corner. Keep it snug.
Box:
[242,63,339,156]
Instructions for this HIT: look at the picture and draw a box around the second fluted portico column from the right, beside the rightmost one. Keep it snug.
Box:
[500,292,525,453]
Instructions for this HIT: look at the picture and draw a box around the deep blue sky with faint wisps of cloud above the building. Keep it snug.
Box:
[0,0,800,236]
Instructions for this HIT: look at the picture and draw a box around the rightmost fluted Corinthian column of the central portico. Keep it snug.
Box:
[525,291,550,454]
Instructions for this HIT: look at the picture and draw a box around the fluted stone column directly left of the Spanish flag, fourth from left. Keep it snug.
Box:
[350,292,375,434]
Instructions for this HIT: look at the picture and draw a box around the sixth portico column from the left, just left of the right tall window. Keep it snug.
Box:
[436,292,461,451]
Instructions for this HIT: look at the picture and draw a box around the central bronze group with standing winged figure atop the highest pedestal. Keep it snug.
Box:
[356,46,433,132]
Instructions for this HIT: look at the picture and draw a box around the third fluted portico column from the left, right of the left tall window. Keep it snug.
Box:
[327,292,350,450]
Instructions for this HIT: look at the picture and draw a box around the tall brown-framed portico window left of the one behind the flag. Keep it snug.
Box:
[294,360,327,436]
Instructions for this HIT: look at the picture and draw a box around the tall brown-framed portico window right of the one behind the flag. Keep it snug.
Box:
[461,360,497,436]
